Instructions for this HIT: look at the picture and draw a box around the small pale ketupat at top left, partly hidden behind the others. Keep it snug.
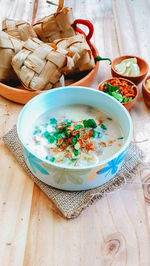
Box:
[2,19,37,41]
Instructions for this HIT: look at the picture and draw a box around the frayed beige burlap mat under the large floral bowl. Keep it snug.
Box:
[3,126,142,219]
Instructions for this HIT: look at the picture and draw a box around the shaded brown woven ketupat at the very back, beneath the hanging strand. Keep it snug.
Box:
[33,7,75,42]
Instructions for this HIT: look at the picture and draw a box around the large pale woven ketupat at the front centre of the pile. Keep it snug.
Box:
[12,38,66,90]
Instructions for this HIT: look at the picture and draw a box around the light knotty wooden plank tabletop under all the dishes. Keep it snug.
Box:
[0,0,150,266]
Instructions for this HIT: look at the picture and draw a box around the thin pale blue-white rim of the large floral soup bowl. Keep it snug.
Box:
[17,86,133,170]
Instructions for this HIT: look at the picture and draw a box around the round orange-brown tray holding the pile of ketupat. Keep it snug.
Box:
[0,47,99,104]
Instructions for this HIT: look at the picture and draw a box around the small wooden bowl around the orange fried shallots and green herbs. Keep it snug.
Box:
[98,78,139,111]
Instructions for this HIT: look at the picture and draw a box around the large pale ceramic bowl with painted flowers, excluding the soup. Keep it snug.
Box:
[17,87,132,191]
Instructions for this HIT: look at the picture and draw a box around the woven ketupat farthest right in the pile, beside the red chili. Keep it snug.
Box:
[54,34,95,74]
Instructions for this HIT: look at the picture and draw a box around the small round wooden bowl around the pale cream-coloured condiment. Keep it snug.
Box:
[111,55,148,85]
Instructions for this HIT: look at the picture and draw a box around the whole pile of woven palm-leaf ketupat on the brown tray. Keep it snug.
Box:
[0,0,95,90]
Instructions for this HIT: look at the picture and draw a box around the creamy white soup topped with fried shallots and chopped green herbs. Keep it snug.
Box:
[28,104,124,167]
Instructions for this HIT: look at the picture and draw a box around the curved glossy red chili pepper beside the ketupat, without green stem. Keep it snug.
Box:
[73,19,96,58]
